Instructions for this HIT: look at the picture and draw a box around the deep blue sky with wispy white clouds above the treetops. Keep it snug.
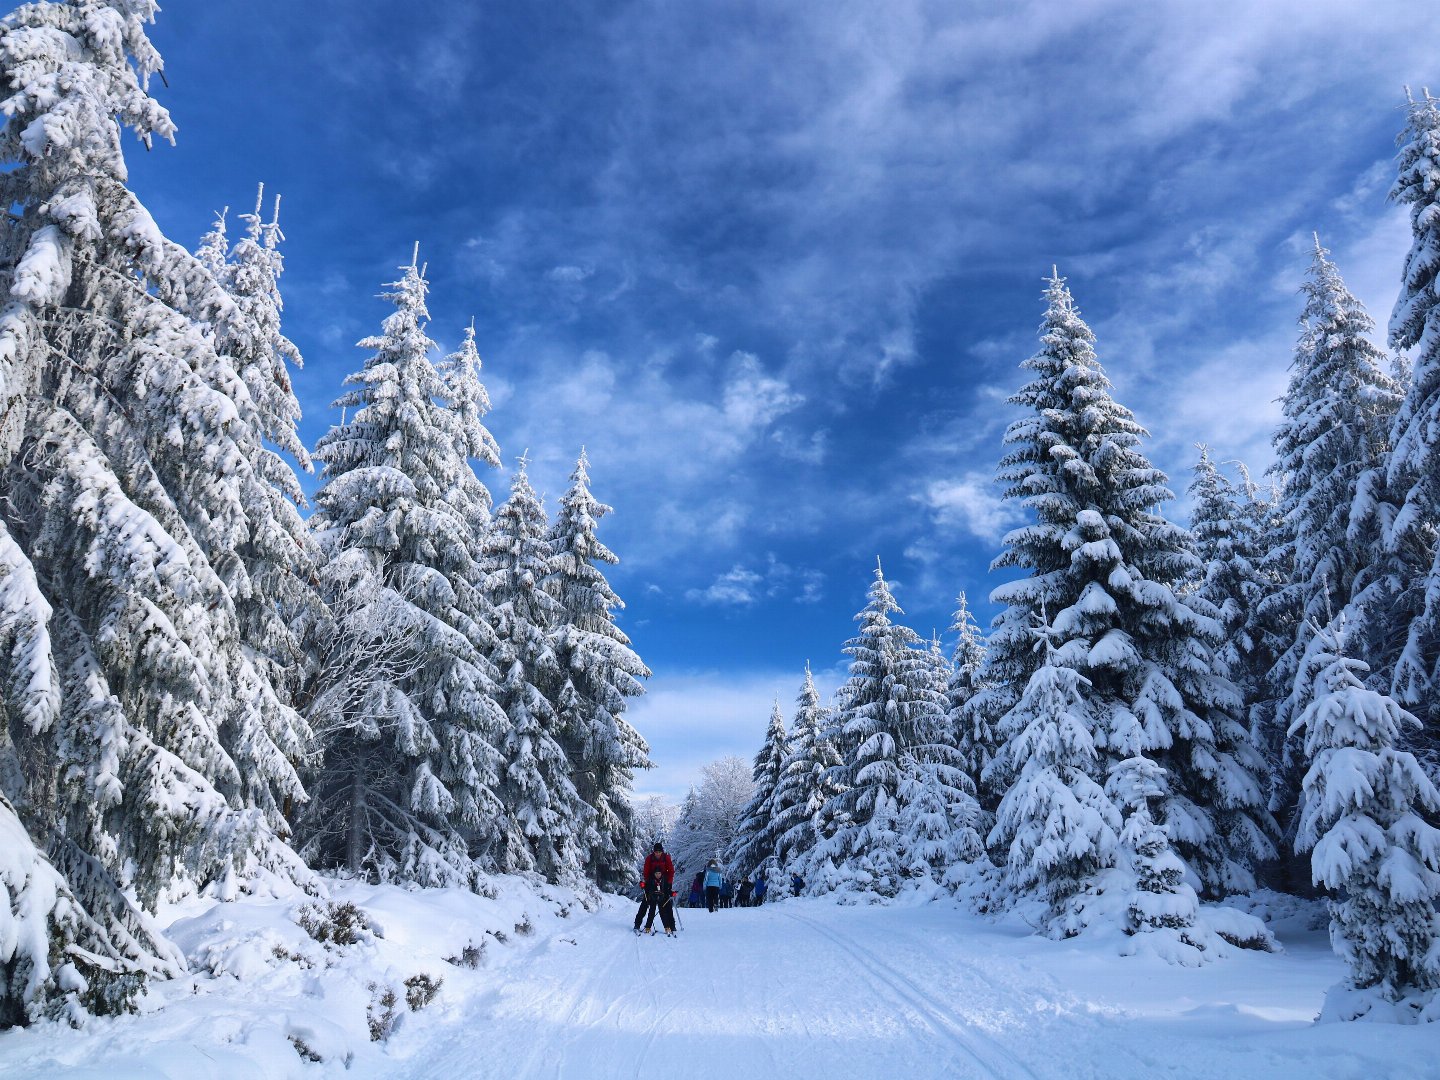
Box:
[130,0,1440,795]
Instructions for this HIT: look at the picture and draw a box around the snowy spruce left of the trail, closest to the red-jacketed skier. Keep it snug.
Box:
[544,449,654,888]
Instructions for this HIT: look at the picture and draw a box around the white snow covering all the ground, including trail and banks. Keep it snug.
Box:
[0,880,1440,1080]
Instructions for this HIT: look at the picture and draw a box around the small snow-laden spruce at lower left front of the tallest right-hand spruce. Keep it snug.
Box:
[986,641,1122,936]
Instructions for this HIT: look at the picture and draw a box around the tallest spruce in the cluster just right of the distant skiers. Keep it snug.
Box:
[809,560,953,896]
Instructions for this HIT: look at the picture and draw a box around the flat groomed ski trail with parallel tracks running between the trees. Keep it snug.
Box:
[389,903,1054,1080]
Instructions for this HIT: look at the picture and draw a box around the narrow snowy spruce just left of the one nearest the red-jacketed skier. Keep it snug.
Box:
[481,456,578,881]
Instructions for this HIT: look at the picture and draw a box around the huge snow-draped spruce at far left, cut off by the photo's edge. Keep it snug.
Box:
[0,0,316,1018]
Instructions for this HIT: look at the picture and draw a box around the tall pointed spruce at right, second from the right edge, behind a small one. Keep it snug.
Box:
[1261,239,1400,837]
